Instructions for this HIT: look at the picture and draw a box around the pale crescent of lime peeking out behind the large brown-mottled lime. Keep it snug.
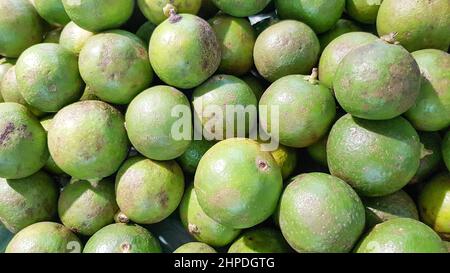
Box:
[319,32,377,88]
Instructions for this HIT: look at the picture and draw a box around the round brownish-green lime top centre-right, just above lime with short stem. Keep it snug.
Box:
[253,20,320,82]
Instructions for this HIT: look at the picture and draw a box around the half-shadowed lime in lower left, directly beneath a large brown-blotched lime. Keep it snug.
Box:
[58,180,118,236]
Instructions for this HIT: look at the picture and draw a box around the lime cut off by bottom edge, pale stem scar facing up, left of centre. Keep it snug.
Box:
[83,224,162,253]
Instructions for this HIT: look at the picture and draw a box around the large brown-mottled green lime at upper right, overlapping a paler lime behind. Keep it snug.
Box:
[333,40,421,120]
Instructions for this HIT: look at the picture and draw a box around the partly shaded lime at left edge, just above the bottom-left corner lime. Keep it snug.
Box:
[0,172,59,233]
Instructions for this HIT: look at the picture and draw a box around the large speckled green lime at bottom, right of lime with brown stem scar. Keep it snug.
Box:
[279,173,365,252]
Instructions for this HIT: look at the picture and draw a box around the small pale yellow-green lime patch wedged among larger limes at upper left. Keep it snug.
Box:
[59,22,95,55]
